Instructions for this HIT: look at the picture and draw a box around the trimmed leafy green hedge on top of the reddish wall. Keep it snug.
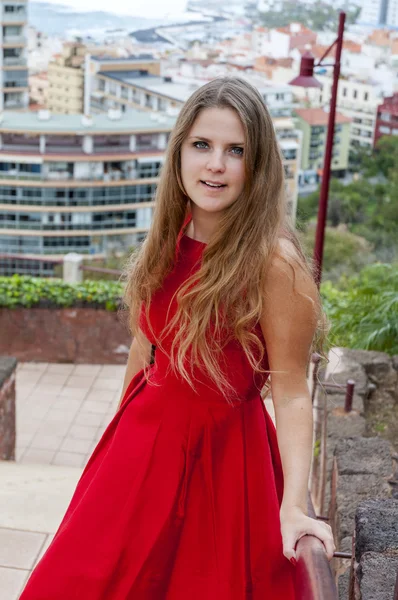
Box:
[0,275,123,311]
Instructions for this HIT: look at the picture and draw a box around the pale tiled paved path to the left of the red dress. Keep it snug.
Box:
[0,363,273,600]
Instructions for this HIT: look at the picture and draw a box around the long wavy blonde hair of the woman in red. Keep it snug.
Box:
[125,77,325,397]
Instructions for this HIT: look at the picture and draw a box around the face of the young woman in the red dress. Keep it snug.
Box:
[181,108,245,213]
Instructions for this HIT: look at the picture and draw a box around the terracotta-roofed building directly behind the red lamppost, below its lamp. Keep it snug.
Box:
[295,108,351,186]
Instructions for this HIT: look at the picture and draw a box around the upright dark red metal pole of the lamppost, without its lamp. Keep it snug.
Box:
[314,12,346,287]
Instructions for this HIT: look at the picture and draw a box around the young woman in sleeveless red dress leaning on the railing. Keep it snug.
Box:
[21,78,335,600]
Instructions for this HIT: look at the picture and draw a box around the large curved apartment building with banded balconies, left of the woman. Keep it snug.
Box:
[0,111,175,275]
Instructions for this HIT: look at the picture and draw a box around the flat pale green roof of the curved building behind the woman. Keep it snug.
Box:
[0,110,176,135]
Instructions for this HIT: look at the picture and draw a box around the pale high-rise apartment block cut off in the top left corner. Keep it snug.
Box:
[0,0,29,111]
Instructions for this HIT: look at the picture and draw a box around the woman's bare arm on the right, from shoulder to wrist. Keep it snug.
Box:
[261,239,317,513]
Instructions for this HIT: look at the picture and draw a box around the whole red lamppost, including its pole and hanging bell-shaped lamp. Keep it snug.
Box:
[290,12,346,287]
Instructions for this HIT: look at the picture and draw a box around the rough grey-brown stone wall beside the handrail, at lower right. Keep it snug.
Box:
[313,348,398,600]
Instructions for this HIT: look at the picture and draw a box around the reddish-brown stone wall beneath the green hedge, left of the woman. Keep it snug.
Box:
[0,308,131,364]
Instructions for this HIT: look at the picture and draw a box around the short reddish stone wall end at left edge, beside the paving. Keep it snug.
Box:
[0,357,17,460]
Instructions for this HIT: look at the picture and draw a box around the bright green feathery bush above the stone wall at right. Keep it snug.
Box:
[321,263,398,355]
